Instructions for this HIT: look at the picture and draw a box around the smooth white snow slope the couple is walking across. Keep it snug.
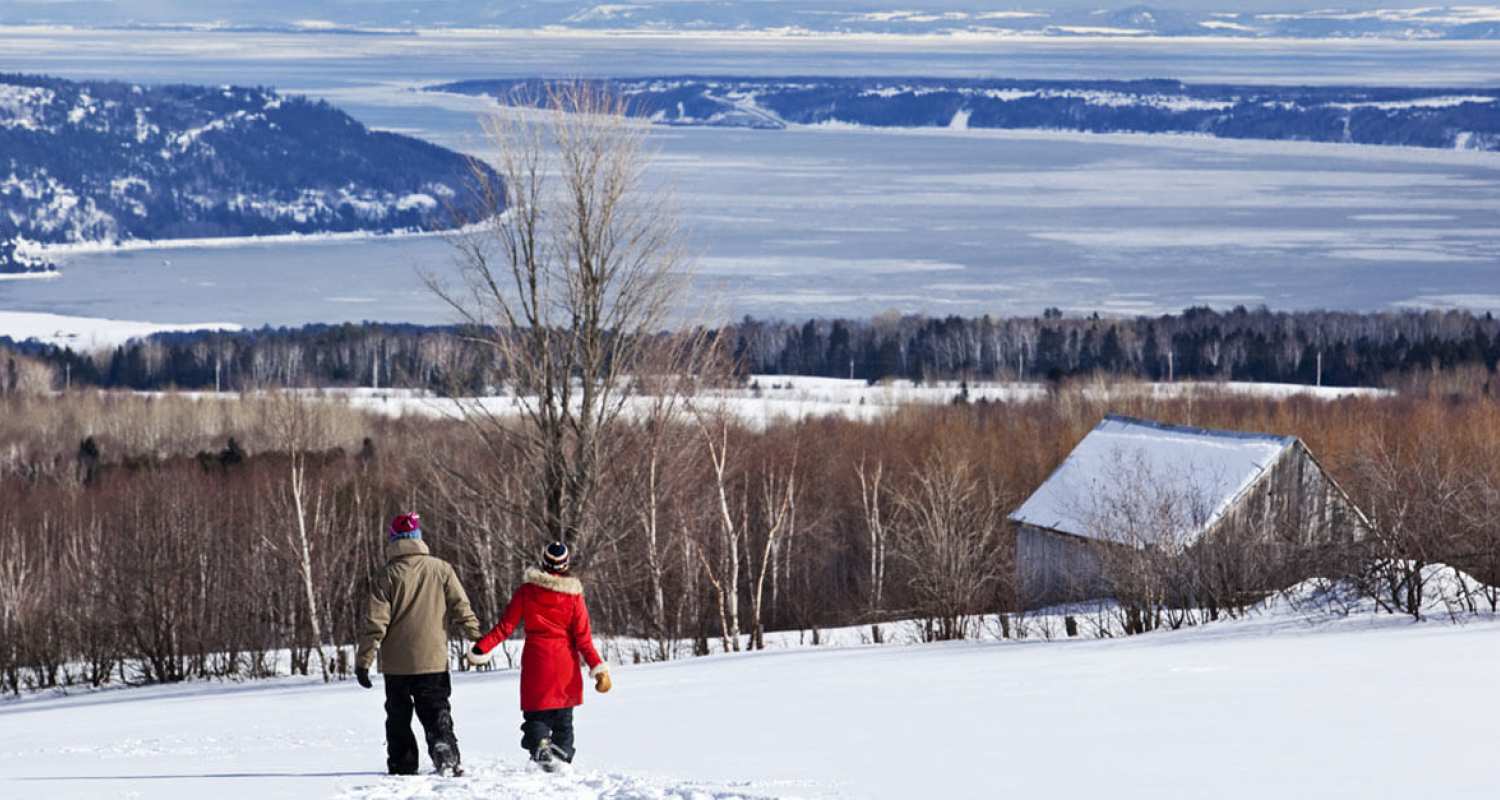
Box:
[0,612,1500,800]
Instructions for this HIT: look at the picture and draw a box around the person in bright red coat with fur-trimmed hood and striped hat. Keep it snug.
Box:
[468,542,612,770]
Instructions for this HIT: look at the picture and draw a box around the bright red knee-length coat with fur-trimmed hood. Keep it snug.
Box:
[479,569,609,711]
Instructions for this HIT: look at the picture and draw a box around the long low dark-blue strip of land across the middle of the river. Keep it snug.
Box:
[432,77,1500,150]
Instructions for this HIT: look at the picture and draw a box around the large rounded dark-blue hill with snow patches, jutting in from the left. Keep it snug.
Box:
[0,74,492,272]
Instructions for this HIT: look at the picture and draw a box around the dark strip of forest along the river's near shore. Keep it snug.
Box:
[0,308,1500,393]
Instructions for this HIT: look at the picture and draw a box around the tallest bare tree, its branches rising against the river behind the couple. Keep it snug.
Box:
[428,83,686,552]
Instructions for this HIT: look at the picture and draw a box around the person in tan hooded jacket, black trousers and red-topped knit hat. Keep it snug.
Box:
[354,513,483,776]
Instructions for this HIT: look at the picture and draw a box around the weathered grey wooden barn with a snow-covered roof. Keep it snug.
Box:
[1010,414,1370,608]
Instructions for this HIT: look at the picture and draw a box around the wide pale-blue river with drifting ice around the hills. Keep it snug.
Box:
[0,32,1500,326]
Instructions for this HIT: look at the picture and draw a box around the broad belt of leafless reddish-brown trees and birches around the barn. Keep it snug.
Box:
[0,382,1500,690]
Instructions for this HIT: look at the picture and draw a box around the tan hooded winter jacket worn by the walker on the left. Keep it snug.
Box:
[356,539,483,675]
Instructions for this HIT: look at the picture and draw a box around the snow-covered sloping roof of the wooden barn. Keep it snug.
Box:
[1011,414,1298,539]
